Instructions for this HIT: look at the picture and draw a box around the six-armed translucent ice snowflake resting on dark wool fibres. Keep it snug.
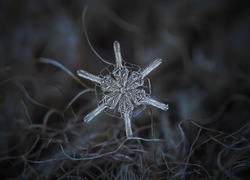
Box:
[77,41,168,138]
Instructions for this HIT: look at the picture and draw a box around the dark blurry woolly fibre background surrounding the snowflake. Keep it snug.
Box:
[0,0,250,179]
